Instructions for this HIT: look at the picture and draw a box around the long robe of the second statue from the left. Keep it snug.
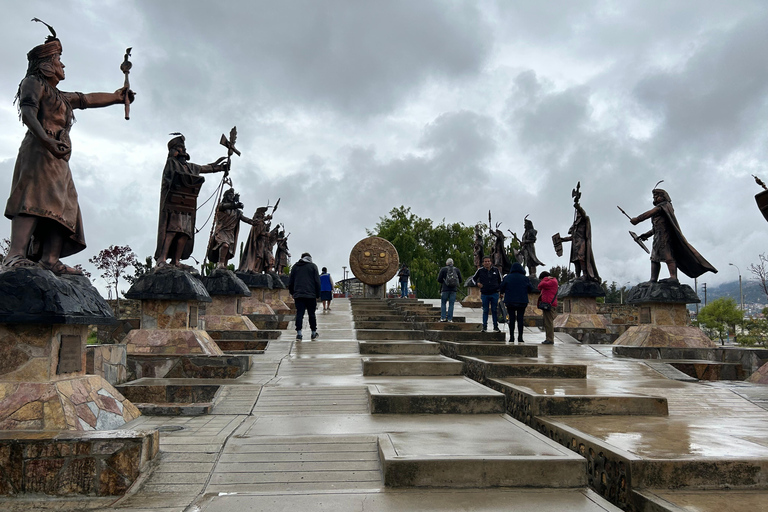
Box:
[155,157,205,260]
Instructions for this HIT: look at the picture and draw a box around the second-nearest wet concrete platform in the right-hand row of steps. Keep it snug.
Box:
[496,378,668,425]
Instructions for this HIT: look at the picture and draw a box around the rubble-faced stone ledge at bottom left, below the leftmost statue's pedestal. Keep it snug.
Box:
[0,430,160,496]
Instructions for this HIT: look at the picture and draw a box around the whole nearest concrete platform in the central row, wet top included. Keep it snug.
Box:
[379,416,586,488]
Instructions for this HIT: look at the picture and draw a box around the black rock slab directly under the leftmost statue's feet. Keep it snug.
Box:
[0,268,115,325]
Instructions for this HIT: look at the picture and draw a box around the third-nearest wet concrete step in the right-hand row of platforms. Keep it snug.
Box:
[459,356,587,383]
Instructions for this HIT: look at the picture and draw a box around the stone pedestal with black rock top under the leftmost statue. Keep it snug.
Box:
[0,268,140,431]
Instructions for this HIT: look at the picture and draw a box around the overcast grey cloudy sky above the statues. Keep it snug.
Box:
[0,0,768,289]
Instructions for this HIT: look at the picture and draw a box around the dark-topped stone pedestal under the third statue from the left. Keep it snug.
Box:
[201,269,258,331]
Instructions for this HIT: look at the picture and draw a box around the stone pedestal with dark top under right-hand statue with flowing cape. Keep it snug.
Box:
[613,282,717,348]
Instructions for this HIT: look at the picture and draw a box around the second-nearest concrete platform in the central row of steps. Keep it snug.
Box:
[368,377,504,414]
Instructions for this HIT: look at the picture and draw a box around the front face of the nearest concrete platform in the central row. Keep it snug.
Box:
[379,436,586,488]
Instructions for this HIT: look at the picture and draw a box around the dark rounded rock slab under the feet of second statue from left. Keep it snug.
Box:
[125,266,211,302]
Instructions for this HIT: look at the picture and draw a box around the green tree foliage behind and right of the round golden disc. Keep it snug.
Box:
[367,206,475,299]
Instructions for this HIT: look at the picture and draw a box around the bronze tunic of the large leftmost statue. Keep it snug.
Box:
[5,76,85,260]
